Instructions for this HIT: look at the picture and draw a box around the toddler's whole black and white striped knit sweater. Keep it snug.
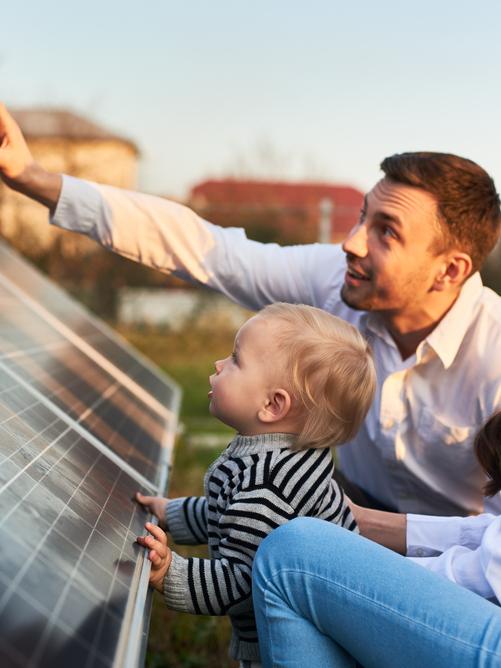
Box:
[164,434,356,661]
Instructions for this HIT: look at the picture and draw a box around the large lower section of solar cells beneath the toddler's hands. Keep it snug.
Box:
[0,369,152,667]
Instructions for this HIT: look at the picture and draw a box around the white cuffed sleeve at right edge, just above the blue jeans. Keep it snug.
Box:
[407,514,501,601]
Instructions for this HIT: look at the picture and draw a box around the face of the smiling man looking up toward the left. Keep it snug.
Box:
[341,178,444,315]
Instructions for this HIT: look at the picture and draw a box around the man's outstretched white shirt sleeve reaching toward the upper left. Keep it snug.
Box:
[51,176,344,309]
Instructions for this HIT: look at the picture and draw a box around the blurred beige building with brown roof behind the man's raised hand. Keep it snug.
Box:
[0,108,139,257]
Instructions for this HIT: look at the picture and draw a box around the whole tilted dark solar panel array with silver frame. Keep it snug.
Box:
[0,246,179,668]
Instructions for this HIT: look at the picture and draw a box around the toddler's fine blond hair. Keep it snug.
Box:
[259,302,376,448]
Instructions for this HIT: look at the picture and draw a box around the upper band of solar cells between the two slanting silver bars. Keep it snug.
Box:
[0,285,170,486]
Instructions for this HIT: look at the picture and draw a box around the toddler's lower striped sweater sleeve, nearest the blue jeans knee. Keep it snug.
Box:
[164,487,296,615]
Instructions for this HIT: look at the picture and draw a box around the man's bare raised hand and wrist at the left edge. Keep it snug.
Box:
[0,103,62,212]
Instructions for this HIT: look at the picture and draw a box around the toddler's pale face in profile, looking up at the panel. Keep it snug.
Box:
[209,315,283,435]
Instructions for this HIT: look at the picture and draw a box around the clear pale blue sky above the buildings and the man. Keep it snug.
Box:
[0,0,501,197]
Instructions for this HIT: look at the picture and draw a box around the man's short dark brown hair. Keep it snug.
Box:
[381,151,501,271]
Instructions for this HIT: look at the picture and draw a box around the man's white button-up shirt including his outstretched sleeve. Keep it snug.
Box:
[52,177,501,515]
